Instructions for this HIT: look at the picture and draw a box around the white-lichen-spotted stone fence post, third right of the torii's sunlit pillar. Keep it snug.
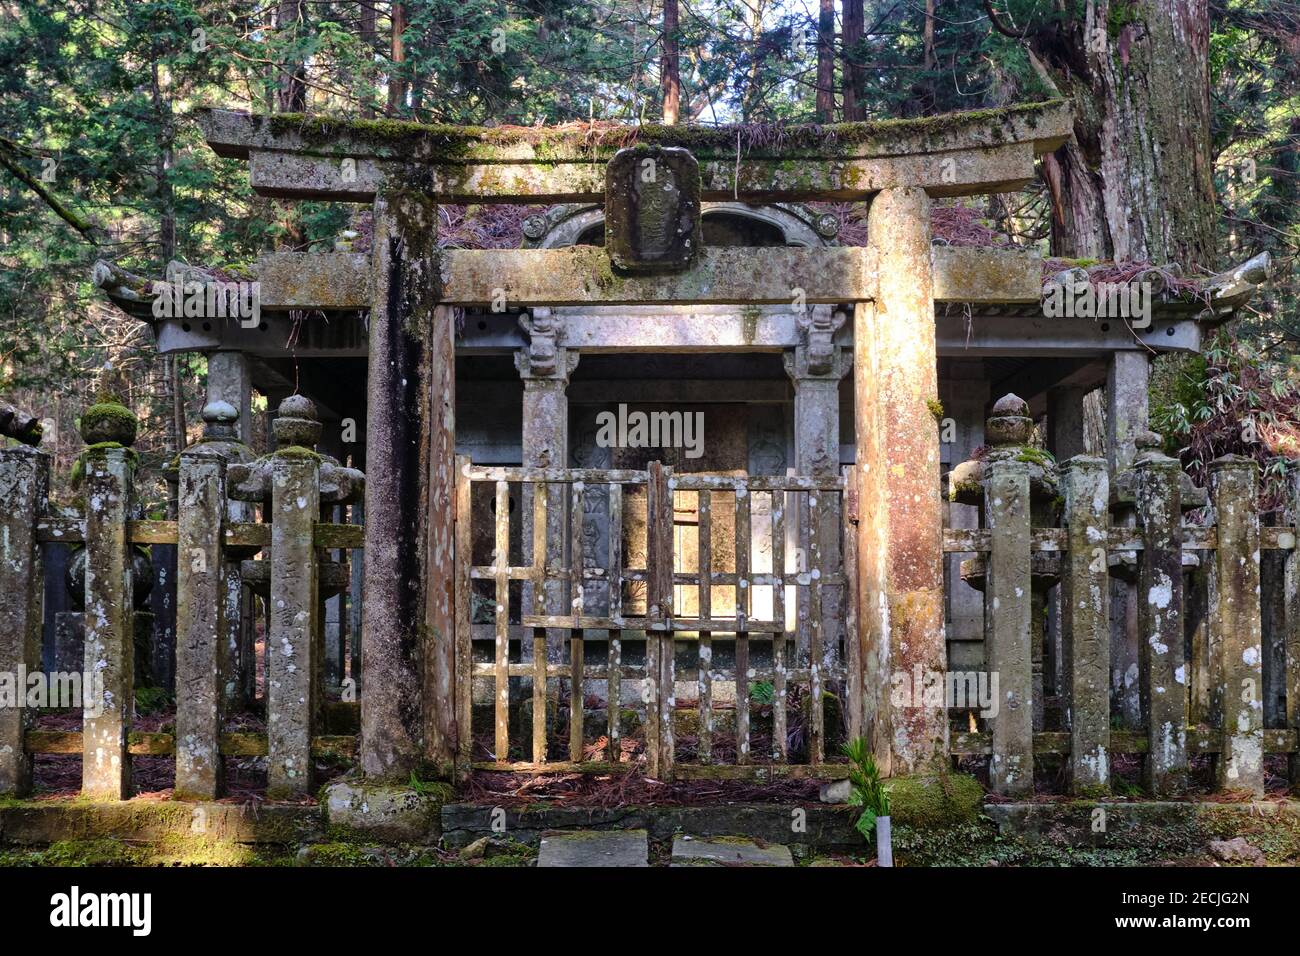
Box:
[1134,433,1187,795]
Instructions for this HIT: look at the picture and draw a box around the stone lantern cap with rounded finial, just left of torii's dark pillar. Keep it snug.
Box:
[230,395,365,505]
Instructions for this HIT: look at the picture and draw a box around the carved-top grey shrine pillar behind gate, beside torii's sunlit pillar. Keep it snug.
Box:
[774,329,857,672]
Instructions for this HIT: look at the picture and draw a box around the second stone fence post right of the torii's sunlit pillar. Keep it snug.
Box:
[1061,455,1110,796]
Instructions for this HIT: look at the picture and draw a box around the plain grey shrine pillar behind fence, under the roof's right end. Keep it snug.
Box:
[1106,351,1151,728]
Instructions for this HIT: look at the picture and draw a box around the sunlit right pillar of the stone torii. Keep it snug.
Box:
[853,189,948,775]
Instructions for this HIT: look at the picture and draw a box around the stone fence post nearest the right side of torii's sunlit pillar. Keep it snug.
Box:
[984,460,1034,796]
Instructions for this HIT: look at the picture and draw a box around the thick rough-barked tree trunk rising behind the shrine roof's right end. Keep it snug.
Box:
[1024,0,1216,271]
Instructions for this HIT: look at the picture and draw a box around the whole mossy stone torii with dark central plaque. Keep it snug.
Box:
[183,103,1070,780]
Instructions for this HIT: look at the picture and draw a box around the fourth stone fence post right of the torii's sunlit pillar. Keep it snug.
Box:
[1209,455,1264,795]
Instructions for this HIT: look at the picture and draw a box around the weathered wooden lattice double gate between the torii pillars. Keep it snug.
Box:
[456,458,862,779]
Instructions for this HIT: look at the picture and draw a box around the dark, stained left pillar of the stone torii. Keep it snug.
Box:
[361,191,456,782]
